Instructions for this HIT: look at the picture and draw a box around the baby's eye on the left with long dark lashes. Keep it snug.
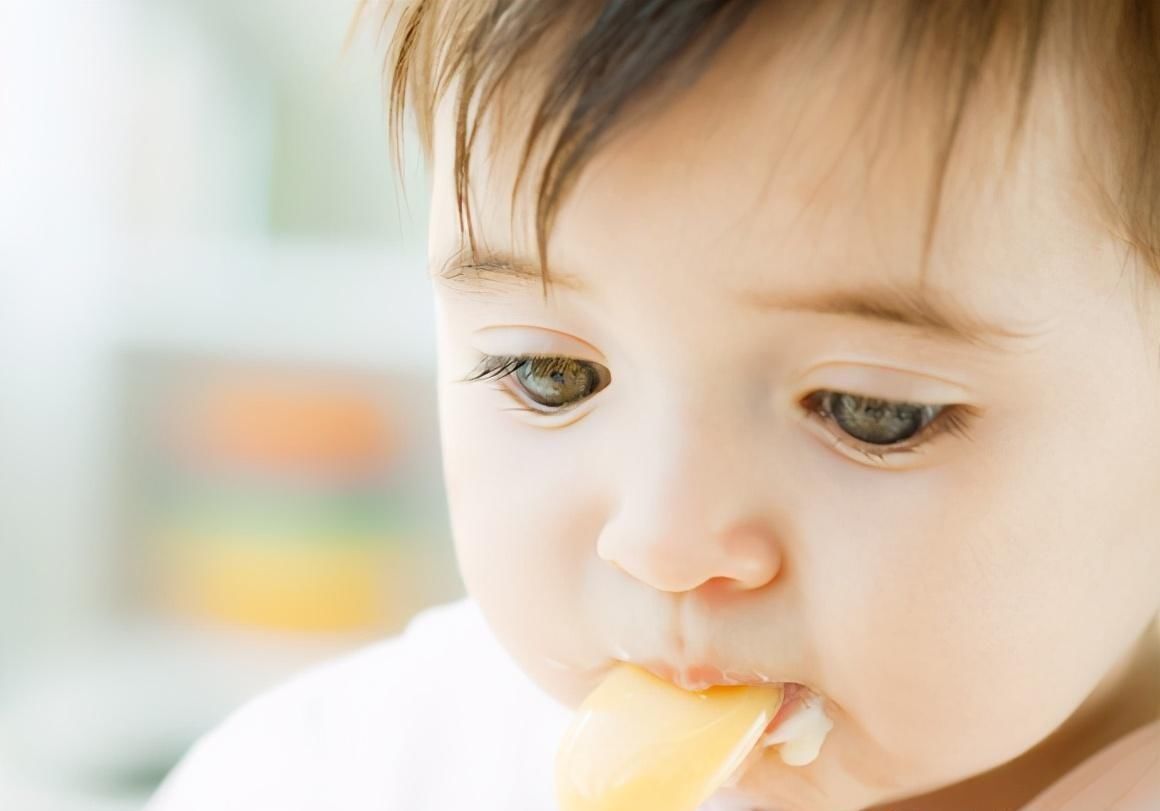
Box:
[466,355,611,413]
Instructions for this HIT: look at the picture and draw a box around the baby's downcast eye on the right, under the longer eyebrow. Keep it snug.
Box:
[804,391,970,461]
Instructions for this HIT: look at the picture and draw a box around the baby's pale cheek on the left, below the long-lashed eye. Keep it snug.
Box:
[440,384,602,703]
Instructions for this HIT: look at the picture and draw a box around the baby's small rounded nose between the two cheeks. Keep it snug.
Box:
[597,390,780,592]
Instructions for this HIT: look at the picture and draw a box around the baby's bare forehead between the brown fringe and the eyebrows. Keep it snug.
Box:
[432,9,1107,334]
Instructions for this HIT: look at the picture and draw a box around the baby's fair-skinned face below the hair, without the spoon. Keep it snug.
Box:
[430,17,1160,809]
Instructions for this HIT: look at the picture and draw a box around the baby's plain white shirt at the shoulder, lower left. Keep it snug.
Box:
[146,599,756,811]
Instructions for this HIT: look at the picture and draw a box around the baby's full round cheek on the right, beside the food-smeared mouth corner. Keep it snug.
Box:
[804,448,1154,784]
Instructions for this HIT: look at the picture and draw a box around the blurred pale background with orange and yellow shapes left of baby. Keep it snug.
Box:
[0,0,462,811]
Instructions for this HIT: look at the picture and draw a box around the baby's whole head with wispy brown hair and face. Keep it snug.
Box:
[389,0,1160,811]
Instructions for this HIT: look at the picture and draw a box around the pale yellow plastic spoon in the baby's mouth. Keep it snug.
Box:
[556,664,782,811]
